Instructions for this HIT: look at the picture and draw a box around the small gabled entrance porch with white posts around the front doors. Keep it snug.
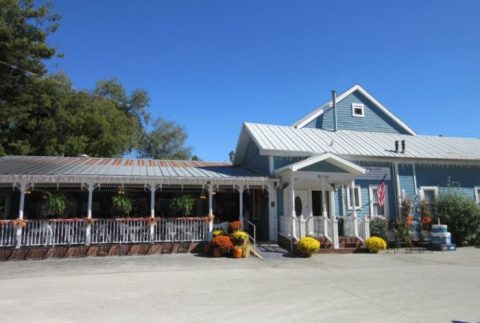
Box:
[276,153,370,249]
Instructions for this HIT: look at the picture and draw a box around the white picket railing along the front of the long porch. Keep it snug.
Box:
[0,217,209,247]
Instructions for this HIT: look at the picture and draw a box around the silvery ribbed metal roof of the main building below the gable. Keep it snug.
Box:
[237,123,480,162]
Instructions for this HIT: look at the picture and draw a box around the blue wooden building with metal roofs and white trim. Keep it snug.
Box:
[0,85,480,252]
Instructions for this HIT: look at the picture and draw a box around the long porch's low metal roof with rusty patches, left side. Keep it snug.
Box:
[0,156,270,183]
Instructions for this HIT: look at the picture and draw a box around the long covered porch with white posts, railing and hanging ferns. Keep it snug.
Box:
[0,157,275,248]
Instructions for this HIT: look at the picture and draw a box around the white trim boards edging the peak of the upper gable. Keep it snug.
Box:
[292,84,415,135]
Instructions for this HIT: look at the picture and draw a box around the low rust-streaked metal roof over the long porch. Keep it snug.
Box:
[0,156,265,180]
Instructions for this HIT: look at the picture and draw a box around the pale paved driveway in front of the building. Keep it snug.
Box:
[0,248,480,322]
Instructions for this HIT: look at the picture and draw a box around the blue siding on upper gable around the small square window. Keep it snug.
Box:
[306,91,408,134]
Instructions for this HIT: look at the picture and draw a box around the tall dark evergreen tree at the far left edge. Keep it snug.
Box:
[0,0,60,155]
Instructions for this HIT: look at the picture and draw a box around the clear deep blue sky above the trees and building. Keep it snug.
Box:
[49,0,480,161]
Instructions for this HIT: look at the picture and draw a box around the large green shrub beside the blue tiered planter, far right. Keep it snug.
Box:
[436,194,480,246]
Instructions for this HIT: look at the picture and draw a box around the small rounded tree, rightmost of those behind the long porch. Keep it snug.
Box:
[138,118,191,159]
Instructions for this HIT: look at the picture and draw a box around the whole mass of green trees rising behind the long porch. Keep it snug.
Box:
[0,0,190,159]
